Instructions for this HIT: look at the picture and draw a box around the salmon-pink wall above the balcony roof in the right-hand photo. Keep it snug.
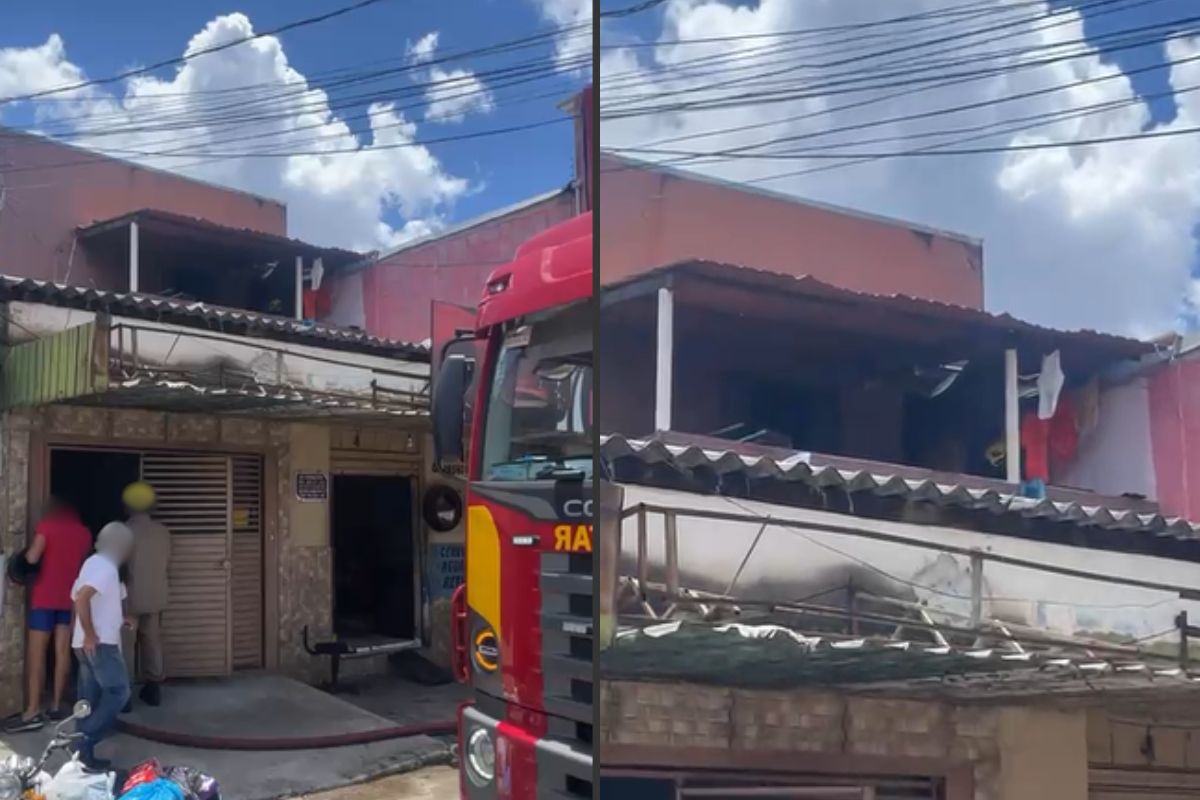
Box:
[600,158,983,308]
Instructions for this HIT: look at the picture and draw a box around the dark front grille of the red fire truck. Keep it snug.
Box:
[540,553,595,798]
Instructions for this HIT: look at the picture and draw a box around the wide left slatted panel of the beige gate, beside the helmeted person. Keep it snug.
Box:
[142,452,233,678]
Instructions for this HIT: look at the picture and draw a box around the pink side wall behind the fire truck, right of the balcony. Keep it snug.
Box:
[328,191,575,342]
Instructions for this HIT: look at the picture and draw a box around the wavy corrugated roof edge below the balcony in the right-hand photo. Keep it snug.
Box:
[600,435,1200,540]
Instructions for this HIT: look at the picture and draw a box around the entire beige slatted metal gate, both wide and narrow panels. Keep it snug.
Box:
[142,452,263,678]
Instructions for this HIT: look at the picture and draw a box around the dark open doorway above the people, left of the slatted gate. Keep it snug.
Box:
[50,449,142,537]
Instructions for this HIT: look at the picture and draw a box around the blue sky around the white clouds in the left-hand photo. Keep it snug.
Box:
[0,0,582,237]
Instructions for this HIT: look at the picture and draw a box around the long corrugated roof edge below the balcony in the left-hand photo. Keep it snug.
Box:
[0,275,431,363]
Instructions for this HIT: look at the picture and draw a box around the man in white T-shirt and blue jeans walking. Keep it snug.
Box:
[71,522,133,770]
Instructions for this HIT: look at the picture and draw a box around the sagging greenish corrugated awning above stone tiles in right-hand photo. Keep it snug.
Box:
[609,621,1200,700]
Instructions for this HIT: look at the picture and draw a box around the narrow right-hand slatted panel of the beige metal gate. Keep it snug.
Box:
[230,456,263,669]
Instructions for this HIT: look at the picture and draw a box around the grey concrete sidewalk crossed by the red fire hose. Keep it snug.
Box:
[0,674,450,800]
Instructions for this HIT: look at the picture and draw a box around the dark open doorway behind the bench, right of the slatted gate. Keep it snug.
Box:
[332,475,416,640]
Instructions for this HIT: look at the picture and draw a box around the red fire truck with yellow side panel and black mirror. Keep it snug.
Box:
[433,213,594,800]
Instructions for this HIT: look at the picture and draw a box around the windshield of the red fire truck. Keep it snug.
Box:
[480,303,592,481]
